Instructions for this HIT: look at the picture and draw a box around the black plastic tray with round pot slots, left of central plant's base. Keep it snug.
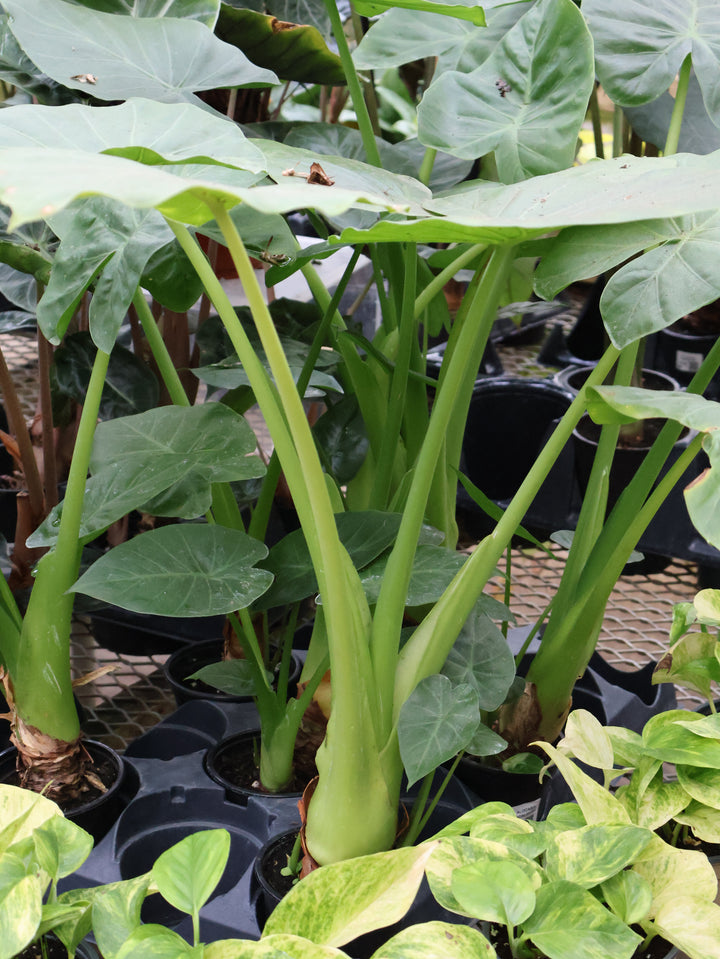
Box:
[61,701,480,942]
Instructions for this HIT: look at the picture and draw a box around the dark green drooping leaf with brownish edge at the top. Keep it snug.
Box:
[215,4,345,86]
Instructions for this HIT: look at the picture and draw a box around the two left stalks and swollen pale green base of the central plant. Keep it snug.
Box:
[170,214,400,862]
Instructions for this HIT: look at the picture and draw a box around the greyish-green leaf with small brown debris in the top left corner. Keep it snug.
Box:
[4,0,278,103]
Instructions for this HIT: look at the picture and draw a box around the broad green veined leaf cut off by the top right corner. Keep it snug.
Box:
[582,0,720,117]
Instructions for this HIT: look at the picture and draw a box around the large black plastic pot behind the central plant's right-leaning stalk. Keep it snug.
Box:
[457,377,573,538]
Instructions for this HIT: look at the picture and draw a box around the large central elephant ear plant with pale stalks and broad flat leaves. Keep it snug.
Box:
[1,3,717,862]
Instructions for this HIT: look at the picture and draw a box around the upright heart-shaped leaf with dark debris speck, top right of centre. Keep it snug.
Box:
[418,0,594,183]
